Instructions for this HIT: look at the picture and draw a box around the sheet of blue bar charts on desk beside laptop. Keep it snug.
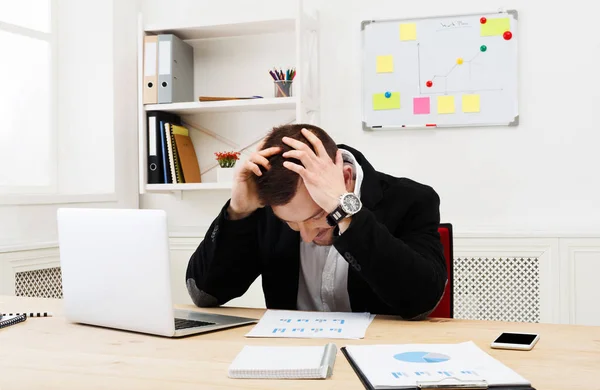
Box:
[246,310,375,339]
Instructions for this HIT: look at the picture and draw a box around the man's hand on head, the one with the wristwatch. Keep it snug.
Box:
[282,129,346,213]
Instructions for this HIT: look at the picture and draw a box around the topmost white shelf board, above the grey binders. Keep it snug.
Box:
[145,18,296,40]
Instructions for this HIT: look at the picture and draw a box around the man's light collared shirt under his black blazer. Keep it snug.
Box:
[297,149,363,312]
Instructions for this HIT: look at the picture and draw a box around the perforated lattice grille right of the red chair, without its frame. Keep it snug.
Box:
[454,257,541,322]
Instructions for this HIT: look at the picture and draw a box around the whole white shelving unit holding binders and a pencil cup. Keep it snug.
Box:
[137,0,320,195]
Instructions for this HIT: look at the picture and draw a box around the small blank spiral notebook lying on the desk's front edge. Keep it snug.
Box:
[228,343,337,379]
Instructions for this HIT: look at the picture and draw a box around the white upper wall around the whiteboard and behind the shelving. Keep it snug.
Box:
[142,0,600,234]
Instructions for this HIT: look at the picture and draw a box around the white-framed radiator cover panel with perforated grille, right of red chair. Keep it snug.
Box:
[453,234,564,323]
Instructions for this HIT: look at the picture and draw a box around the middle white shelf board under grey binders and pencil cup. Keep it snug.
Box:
[144,97,297,115]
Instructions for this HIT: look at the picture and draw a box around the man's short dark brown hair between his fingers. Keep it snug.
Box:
[252,124,338,206]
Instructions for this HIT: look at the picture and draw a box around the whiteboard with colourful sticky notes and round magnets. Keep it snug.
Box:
[361,10,519,130]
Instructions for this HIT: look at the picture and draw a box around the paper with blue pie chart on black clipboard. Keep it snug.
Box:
[342,341,531,389]
